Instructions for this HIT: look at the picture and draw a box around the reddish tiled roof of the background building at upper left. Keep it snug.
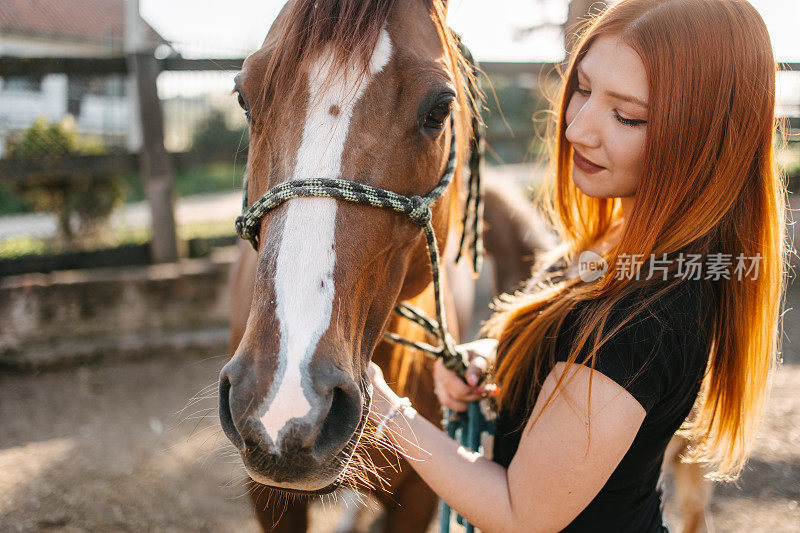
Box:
[0,0,167,48]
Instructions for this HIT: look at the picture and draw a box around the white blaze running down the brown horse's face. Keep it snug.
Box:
[259,29,392,446]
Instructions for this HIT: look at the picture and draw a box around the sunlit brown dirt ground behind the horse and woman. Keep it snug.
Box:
[0,276,800,533]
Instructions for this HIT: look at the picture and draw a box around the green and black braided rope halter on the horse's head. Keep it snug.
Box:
[231,36,483,377]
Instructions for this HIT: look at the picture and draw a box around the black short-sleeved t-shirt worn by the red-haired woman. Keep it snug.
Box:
[493,280,712,533]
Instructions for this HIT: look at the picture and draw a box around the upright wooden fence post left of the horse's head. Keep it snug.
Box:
[128,51,178,263]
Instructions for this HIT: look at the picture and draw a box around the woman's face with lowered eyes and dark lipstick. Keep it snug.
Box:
[566,36,648,210]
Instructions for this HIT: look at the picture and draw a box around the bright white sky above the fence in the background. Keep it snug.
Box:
[139,0,800,62]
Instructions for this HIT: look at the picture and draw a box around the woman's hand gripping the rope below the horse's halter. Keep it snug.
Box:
[433,339,497,411]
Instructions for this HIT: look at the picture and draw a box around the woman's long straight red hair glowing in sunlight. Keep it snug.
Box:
[483,0,787,479]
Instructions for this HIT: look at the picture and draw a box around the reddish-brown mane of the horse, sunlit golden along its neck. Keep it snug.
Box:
[252,0,479,390]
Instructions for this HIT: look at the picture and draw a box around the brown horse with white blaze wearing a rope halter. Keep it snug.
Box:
[219,0,488,532]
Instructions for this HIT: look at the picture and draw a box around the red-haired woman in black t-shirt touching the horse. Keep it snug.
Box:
[371,0,786,532]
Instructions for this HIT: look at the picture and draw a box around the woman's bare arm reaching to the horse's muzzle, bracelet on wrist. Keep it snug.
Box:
[372,362,645,533]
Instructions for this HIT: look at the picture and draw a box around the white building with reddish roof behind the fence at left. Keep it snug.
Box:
[0,0,169,156]
